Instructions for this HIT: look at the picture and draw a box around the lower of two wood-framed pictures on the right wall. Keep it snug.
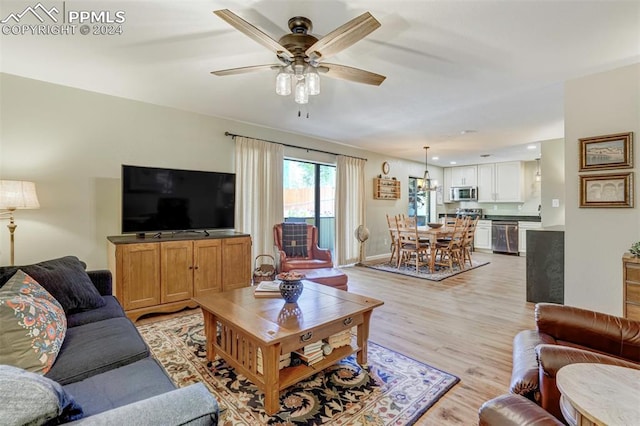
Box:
[580,172,633,207]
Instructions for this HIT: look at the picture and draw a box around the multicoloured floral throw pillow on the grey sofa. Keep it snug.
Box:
[0,270,67,374]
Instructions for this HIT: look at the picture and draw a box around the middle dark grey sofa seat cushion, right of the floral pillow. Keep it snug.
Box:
[46,318,149,385]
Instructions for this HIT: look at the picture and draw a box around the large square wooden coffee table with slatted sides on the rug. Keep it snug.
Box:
[194,281,383,415]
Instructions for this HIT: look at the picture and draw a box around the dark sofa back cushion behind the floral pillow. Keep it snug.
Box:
[0,256,105,314]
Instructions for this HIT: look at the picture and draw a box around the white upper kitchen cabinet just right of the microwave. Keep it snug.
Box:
[478,161,524,203]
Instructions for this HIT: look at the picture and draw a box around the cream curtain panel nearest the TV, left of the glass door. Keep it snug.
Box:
[235,136,284,259]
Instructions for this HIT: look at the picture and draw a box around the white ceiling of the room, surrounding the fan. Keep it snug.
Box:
[0,0,640,166]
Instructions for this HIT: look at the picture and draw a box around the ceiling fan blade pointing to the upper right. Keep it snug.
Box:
[305,12,380,61]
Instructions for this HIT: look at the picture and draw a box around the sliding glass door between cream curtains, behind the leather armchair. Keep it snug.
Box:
[283,159,336,251]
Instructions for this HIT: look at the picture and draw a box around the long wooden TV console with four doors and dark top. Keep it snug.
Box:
[107,231,251,321]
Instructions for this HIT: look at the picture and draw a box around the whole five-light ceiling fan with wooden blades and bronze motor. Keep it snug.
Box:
[211,9,386,103]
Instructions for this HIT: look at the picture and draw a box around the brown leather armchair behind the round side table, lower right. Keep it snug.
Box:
[479,303,640,425]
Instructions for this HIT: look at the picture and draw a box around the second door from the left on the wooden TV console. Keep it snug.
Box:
[160,241,193,303]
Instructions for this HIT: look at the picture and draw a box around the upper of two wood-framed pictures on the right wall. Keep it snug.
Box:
[580,132,633,172]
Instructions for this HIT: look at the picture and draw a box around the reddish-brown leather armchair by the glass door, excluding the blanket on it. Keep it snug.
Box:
[273,223,333,272]
